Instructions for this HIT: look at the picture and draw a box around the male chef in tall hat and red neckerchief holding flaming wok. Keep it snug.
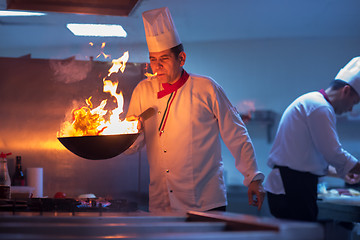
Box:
[127,8,265,212]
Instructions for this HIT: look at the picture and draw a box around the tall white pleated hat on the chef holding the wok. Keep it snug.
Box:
[142,7,181,52]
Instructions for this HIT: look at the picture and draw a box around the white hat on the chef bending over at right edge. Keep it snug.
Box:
[335,57,360,95]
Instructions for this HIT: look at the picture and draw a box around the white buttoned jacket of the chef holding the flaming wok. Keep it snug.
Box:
[127,71,264,212]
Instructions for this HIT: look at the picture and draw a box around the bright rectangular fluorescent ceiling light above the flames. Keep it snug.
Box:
[66,23,127,37]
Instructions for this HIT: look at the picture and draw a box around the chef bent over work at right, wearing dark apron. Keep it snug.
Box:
[265,57,360,221]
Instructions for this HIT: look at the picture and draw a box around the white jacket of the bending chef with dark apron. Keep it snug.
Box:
[264,92,357,194]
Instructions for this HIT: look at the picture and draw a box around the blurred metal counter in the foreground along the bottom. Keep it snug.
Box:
[0,211,324,240]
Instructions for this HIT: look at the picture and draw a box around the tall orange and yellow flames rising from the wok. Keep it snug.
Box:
[58,50,138,137]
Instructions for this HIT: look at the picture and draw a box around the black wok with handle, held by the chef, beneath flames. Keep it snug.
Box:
[58,108,155,160]
